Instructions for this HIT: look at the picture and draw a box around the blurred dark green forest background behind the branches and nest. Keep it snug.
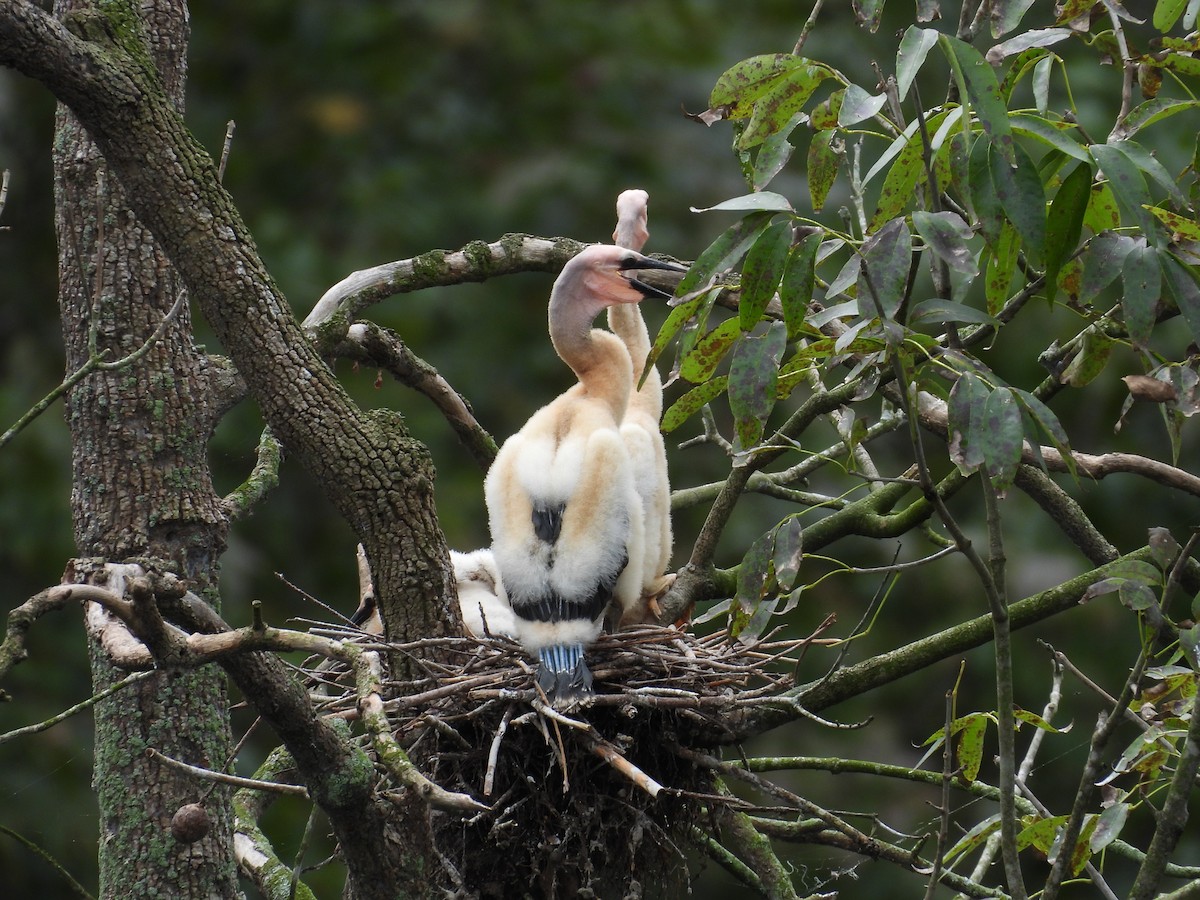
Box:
[0,0,1195,900]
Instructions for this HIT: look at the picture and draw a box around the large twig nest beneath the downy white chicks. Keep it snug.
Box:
[307,626,811,898]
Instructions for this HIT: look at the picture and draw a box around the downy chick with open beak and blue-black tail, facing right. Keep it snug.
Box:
[484,245,678,706]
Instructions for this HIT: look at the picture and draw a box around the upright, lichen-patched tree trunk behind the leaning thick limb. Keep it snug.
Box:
[54,0,238,898]
